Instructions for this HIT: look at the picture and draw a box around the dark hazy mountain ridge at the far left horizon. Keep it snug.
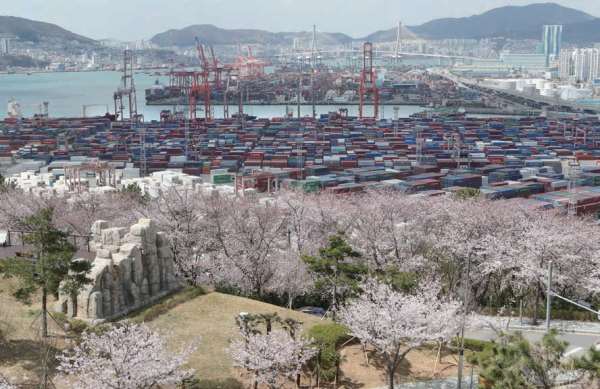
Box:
[0,16,96,44]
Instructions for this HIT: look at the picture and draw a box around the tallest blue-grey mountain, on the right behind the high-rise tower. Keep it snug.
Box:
[364,3,600,43]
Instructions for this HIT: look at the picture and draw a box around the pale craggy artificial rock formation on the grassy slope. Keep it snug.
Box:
[54,219,181,324]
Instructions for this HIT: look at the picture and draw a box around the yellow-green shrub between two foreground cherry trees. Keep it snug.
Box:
[308,323,352,379]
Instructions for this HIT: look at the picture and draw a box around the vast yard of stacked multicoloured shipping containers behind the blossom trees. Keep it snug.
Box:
[0,113,600,214]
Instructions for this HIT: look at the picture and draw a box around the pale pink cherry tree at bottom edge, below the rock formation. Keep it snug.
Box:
[57,321,198,389]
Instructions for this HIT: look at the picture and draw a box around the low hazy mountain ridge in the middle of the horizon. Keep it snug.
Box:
[151,24,353,47]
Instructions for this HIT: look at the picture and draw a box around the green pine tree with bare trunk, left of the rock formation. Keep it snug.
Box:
[5,207,92,338]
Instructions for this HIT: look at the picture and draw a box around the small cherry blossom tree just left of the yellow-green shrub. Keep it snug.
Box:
[226,326,316,389]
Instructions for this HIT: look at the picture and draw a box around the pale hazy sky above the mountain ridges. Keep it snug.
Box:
[0,0,600,40]
